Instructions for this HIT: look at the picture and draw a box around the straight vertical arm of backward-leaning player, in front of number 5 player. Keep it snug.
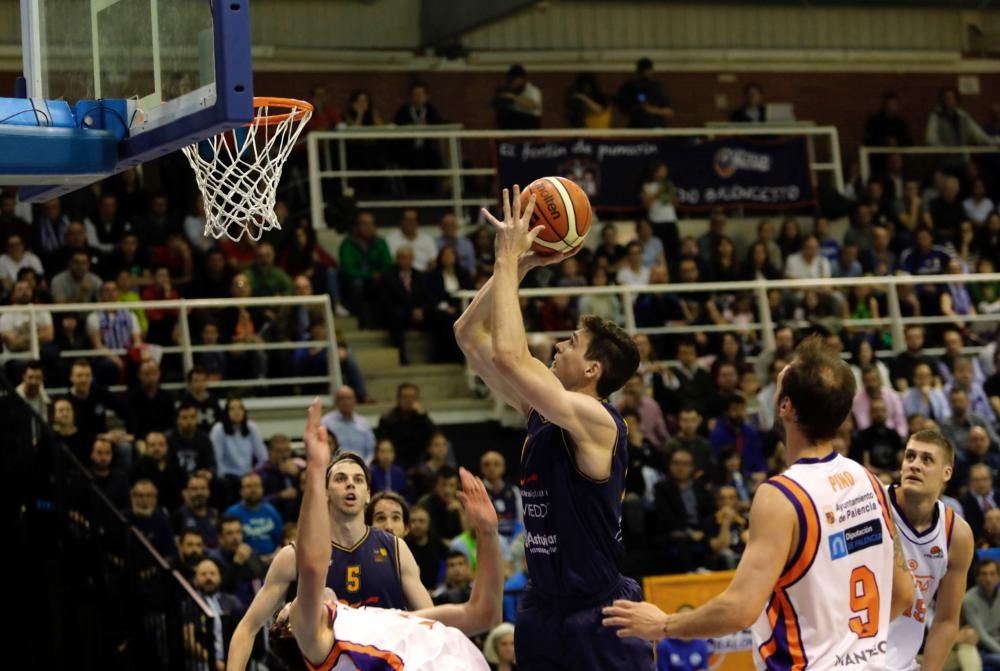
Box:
[289,398,334,665]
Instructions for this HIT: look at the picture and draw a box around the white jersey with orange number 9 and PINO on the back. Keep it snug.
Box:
[751,452,895,671]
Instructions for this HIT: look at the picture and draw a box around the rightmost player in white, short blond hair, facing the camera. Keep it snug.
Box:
[885,431,974,671]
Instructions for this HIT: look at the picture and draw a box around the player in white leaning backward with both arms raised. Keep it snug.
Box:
[271,399,503,671]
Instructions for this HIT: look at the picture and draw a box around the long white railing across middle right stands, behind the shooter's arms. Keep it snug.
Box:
[457,273,1000,388]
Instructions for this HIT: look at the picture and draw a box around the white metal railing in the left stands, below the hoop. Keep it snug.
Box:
[0,295,343,397]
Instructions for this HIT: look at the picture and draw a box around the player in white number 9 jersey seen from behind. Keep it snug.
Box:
[604,336,913,671]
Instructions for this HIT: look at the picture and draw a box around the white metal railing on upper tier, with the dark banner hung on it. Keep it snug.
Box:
[306,124,844,225]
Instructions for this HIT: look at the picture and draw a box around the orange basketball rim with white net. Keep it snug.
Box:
[183,98,313,242]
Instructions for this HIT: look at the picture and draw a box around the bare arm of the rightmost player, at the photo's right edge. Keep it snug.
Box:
[920,515,974,671]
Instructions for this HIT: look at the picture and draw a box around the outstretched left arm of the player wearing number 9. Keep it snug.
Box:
[604,486,796,641]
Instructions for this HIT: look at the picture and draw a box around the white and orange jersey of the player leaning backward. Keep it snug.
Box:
[304,602,489,671]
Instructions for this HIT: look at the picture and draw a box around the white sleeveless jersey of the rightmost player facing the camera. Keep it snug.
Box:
[885,485,955,671]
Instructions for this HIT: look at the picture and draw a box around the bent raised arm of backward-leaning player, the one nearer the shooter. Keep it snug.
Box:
[417,468,503,635]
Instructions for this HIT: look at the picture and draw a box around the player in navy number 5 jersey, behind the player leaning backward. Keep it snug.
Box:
[226,452,433,671]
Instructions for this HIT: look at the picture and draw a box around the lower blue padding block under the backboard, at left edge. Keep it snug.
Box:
[0,124,118,175]
